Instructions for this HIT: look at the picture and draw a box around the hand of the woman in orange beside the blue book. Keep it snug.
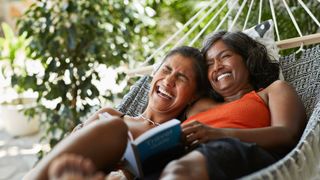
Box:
[181,121,224,148]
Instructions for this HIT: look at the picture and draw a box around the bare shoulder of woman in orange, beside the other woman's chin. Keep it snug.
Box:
[186,98,218,118]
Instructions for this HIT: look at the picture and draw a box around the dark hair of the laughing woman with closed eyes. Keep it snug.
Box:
[162,46,210,96]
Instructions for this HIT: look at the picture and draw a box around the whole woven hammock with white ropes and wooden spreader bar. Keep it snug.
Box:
[117,0,320,180]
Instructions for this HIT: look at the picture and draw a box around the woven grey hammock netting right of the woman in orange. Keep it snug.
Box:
[243,45,320,180]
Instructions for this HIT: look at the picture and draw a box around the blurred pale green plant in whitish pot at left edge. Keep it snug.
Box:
[0,23,39,136]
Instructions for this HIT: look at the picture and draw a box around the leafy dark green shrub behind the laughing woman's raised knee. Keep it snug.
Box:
[13,0,166,156]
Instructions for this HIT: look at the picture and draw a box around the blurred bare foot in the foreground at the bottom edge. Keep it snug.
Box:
[48,154,105,180]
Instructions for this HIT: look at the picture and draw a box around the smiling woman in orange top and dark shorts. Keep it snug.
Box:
[162,31,306,179]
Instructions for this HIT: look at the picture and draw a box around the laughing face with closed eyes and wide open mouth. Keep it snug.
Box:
[148,54,196,117]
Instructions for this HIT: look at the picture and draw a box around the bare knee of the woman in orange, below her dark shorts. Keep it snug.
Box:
[160,151,209,180]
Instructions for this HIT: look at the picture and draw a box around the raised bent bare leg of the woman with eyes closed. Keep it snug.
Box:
[25,117,128,180]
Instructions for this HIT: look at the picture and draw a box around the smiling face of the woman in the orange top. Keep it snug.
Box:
[205,40,251,97]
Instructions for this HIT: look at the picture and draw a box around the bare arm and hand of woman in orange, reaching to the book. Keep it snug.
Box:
[182,81,306,152]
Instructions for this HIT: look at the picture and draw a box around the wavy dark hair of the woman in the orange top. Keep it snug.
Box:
[201,31,279,100]
